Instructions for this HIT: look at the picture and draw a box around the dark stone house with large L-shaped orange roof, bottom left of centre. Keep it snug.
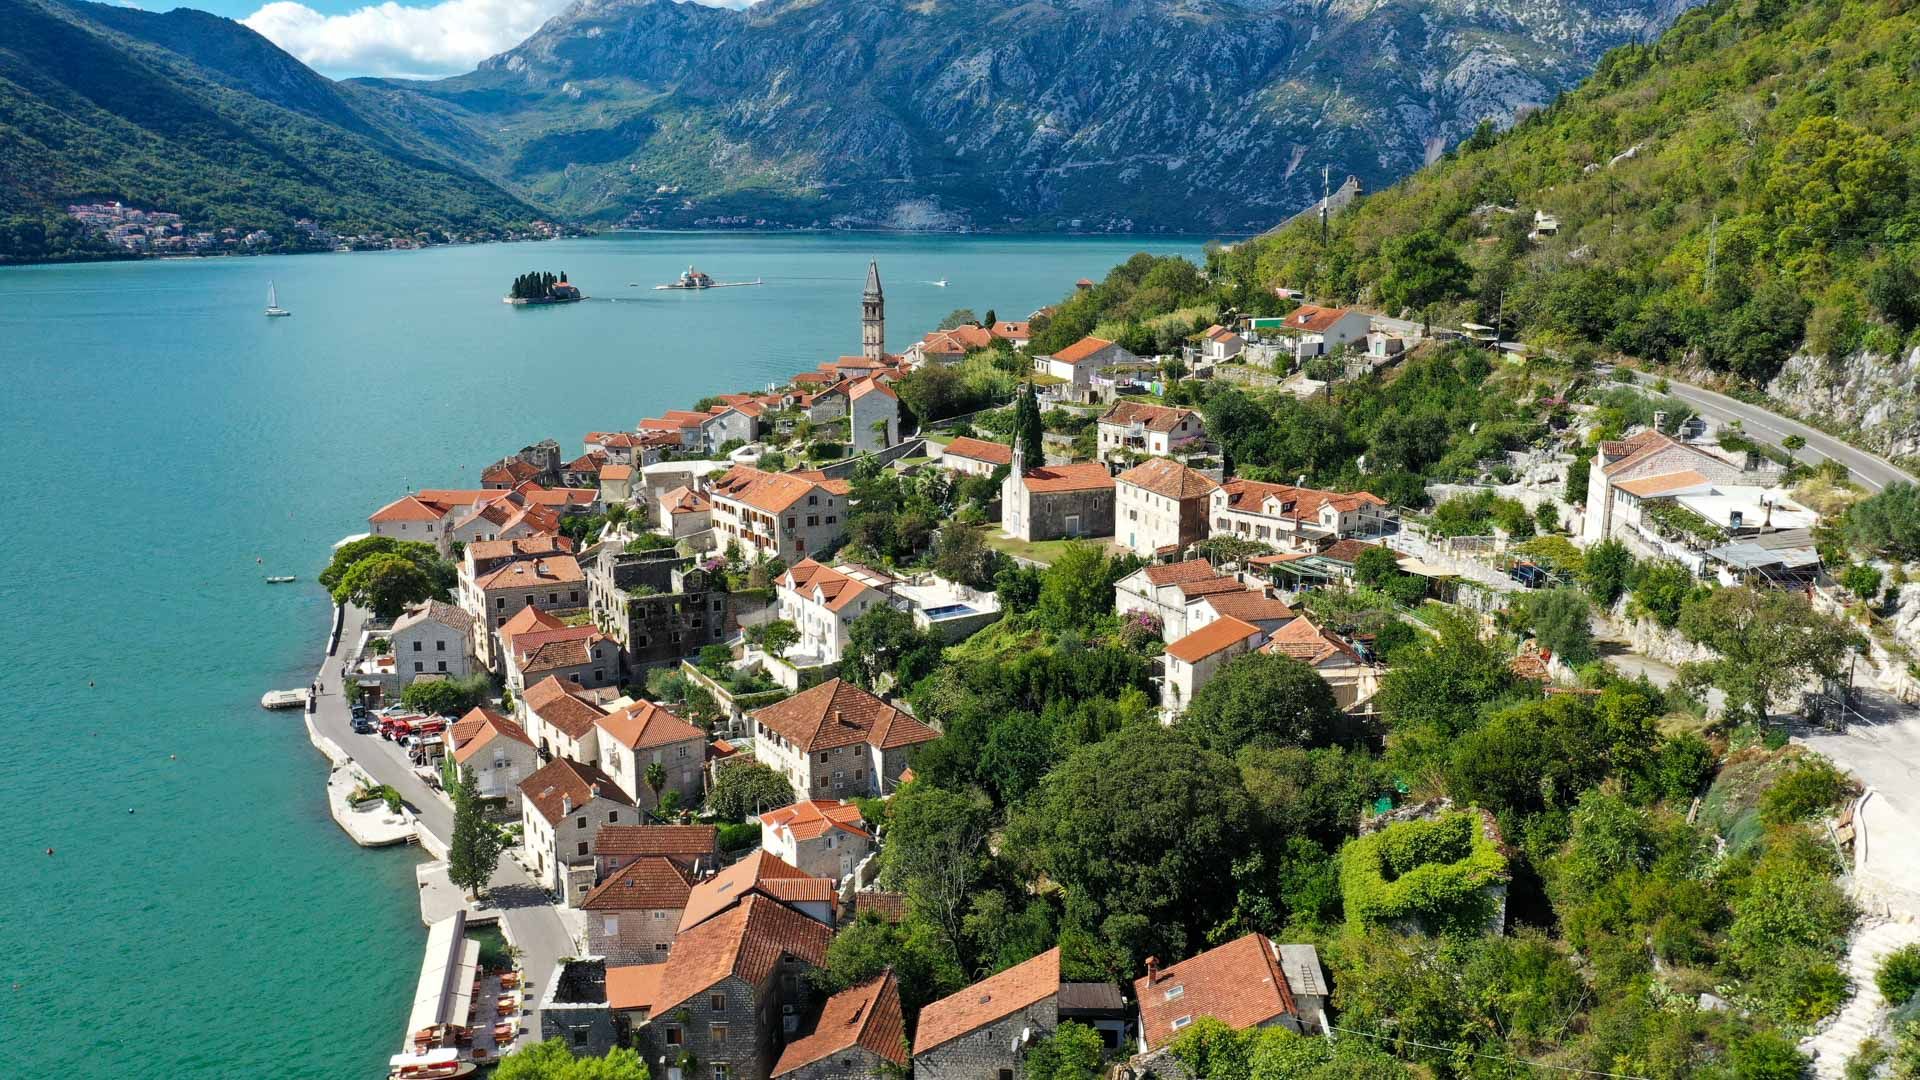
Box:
[636,896,833,1080]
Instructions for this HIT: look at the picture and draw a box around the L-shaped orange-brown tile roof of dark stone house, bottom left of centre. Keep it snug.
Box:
[653,896,833,1015]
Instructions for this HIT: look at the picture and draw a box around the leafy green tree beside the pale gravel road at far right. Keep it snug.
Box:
[1680,586,1864,721]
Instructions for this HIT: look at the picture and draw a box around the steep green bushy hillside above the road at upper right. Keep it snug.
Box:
[1217,0,1920,382]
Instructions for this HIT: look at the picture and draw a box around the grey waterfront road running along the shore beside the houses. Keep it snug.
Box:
[313,607,580,1045]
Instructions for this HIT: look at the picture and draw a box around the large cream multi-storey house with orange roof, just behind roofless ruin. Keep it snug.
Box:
[707,465,849,563]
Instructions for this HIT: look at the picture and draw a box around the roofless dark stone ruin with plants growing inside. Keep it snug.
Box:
[586,544,733,676]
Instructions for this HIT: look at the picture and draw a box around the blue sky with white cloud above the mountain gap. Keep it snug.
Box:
[131,0,753,79]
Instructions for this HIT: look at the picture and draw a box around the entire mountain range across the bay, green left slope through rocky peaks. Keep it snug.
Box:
[0,0,1680,256]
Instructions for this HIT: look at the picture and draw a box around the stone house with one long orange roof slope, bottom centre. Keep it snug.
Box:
[914,945,1060,1080]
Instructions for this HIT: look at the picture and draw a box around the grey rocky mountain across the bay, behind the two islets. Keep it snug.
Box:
[376,0,1676,231]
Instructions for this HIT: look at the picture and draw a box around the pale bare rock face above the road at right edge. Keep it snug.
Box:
[1766,348,1920,459]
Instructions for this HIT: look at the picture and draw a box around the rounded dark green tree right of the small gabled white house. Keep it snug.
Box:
[1177,653,1356,755]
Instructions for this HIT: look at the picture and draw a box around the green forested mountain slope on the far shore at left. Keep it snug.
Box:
[0,0,534,261]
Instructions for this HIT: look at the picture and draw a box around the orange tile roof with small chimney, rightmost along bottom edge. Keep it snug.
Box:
[1128,934,1296,1049]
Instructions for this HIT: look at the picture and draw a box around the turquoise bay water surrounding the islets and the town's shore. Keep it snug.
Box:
[0,234,1198,1078]
